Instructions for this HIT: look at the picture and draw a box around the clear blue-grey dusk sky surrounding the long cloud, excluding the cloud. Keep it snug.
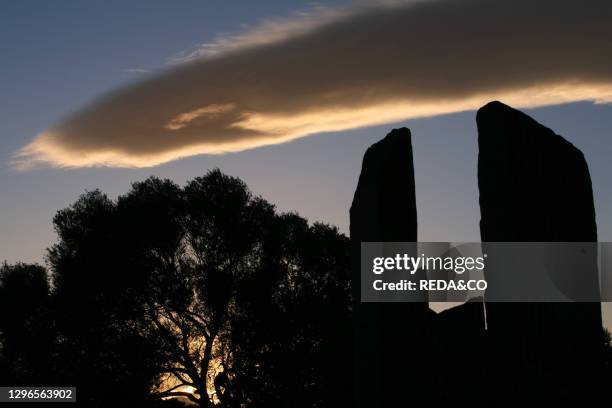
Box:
[0,0,612,326]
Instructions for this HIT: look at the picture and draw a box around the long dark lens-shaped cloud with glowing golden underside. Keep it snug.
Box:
[14,0,612,168]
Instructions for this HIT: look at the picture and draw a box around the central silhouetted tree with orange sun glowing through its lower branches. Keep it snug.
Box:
[119,171,274,406]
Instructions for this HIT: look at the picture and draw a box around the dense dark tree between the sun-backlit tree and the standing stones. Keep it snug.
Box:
[231,214,352,407]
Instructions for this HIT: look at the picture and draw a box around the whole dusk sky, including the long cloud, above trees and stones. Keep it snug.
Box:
[0,0,612,326]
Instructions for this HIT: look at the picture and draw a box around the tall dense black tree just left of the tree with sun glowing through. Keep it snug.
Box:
[48,191,167,406]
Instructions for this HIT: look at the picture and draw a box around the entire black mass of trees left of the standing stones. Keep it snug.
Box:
[0,170,352,407]
